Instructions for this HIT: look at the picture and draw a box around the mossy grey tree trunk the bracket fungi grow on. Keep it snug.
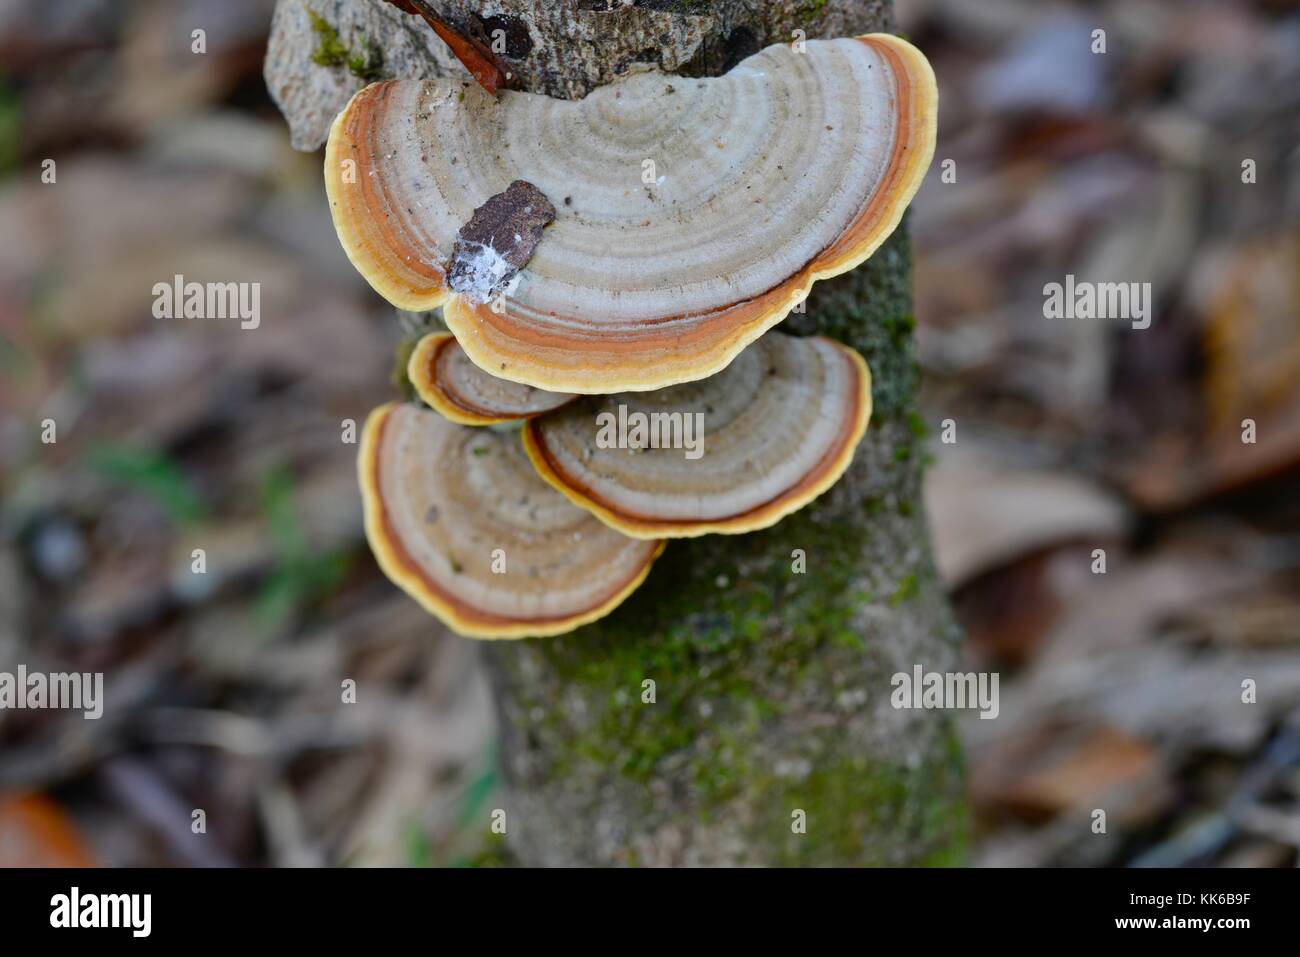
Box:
[267,0,967,865]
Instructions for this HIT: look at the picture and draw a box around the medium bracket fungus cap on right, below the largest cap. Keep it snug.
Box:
[524,333,871,538]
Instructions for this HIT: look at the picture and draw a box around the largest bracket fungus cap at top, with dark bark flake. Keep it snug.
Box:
[325,34,937,394]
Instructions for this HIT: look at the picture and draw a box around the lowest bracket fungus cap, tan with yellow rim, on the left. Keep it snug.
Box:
[359,403,663,638]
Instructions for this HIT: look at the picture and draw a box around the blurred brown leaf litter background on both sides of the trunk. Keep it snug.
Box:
[0,0,1300,866]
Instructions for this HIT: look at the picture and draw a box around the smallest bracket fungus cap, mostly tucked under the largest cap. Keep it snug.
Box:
[407,333,577,425]
